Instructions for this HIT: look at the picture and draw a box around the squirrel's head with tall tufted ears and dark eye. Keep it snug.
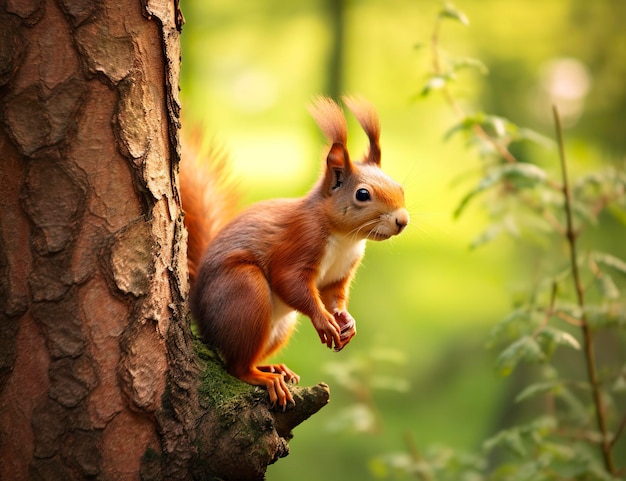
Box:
[311,97,409,240]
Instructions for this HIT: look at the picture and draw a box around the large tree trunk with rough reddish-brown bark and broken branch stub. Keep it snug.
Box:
[0,0,328,480]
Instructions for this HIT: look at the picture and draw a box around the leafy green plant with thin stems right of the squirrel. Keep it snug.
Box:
[370,3,626,481]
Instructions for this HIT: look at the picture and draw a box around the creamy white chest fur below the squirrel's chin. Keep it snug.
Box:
[316,235,365,287]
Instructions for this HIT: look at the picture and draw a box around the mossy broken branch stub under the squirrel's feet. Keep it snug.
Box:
[192,341,330,481]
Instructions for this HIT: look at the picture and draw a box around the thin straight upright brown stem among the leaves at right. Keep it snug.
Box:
[552,106,616,475]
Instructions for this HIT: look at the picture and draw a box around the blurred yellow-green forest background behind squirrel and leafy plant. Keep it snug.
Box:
[181,0,626,480]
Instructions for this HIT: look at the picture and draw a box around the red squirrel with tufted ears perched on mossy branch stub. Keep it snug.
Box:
[181,97,409,409]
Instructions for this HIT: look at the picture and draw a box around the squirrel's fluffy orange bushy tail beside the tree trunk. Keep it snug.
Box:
[180,133,239,284]
